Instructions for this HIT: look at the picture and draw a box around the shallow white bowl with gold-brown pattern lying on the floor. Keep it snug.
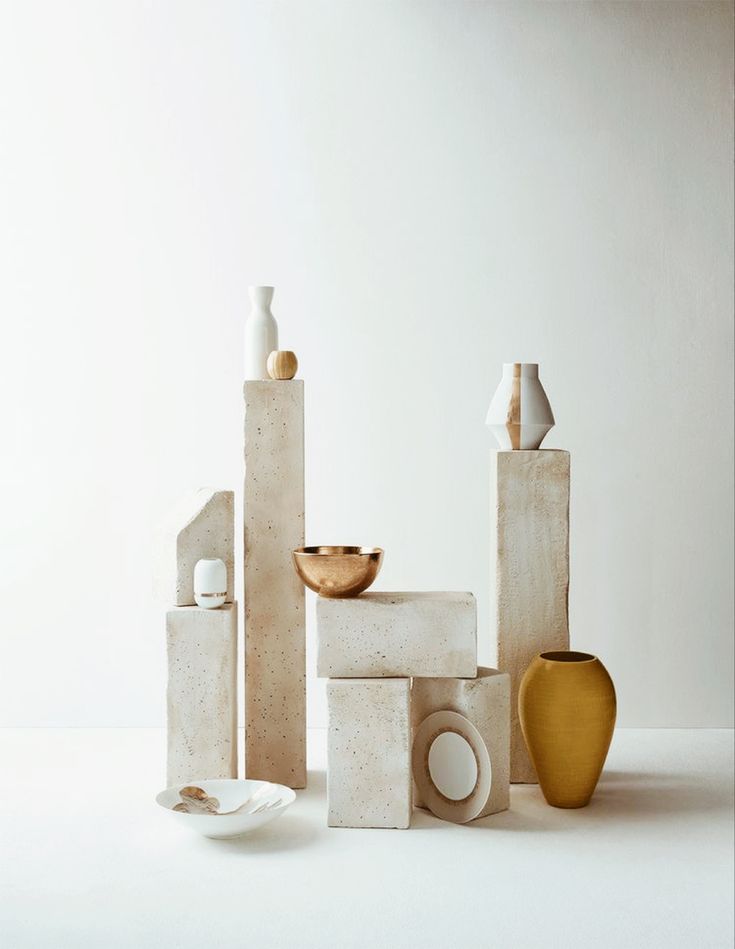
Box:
[156,778,296,839]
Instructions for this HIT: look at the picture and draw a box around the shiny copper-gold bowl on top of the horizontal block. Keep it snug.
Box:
[291,547,383,597]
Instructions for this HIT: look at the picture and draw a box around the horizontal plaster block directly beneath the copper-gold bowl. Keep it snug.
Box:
[316,593,477,678]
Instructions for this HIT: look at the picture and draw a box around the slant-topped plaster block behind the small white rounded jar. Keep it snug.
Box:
[155,488,235,606]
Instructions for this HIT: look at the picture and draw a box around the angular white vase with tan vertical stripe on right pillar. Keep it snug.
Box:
[485,362,554,450]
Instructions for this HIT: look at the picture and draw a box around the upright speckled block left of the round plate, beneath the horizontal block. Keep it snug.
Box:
[327,679,411,827]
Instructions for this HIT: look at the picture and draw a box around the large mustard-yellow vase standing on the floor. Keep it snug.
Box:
[518,652,617,807]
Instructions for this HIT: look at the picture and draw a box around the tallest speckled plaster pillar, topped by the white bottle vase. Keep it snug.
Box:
[244,379,306,788]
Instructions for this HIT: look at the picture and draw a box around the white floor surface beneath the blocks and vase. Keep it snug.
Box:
[0,729,733,949]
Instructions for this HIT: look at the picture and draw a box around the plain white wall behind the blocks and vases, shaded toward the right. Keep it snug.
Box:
[0,0,733,726]
